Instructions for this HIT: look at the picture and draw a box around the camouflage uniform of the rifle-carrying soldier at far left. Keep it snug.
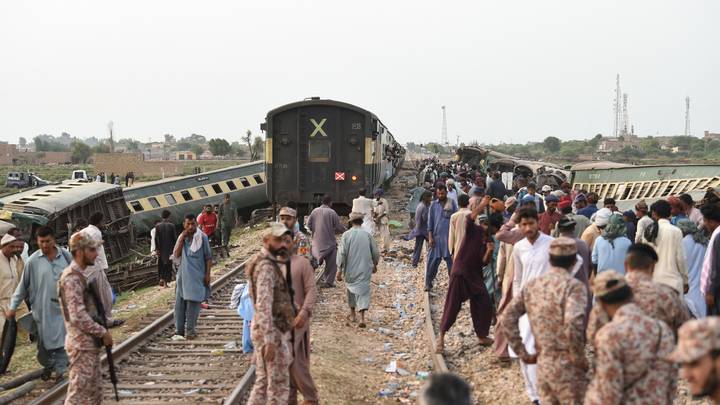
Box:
[58,260,106,404]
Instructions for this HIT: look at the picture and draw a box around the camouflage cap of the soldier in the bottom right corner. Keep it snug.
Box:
[668,316,720,363]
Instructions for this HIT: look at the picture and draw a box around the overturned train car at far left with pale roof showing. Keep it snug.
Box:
[0,180,132,263]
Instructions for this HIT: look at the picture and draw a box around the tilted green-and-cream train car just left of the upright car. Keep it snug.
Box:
[123,161,267,235]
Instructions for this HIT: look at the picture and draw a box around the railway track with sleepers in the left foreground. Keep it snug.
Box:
[22,263,255,405]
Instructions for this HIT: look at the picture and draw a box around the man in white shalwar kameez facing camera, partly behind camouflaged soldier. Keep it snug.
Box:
[509,207,553,403]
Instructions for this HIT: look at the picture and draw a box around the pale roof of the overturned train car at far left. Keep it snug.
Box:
[0,181,120,215]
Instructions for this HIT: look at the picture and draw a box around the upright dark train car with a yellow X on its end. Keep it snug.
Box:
[260,97,405,215]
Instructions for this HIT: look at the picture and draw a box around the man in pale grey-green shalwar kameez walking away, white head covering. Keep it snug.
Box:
[337,212,380,328]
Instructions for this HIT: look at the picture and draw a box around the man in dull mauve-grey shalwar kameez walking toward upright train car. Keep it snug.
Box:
[308,195,345,288]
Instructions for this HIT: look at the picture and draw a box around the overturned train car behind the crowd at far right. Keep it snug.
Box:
[571,162,720,209]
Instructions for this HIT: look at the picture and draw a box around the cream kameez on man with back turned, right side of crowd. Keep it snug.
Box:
[643,219,688,296]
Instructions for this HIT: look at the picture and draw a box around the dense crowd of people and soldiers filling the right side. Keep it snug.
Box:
[409,161,720,404]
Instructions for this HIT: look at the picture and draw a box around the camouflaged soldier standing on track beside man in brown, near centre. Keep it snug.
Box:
[247,222,295,405]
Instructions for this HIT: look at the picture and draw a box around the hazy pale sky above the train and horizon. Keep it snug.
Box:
[0,0,720,143]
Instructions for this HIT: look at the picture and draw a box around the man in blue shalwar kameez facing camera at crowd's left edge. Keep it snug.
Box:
[425,184,457,291]
